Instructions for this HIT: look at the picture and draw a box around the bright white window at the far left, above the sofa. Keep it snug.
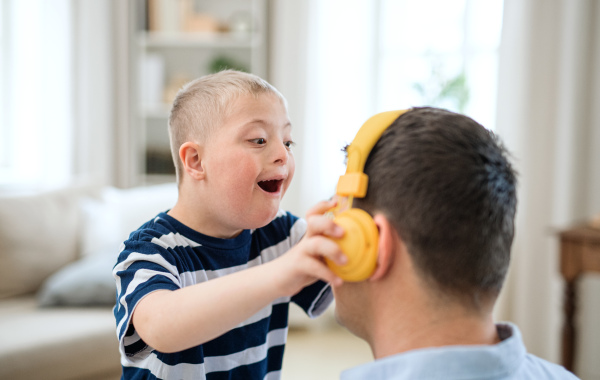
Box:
[0,0,73,190]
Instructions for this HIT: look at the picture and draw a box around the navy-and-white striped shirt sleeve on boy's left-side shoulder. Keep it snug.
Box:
[113,234,181,364]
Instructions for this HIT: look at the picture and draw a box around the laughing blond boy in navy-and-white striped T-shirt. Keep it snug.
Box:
[113,70,345,379]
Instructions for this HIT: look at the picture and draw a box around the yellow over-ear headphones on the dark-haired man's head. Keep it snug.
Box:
[326,110,408,281]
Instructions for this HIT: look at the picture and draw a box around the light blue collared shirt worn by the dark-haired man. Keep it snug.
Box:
[341,323,577,380]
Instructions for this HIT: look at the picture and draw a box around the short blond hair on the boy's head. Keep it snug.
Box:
[169,70,287,183]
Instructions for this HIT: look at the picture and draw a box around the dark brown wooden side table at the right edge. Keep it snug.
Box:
[559,225,600,371]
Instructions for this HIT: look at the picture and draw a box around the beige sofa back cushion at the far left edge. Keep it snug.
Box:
[0,187,95,299]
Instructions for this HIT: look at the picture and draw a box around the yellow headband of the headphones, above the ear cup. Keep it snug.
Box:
[336,110,408,198]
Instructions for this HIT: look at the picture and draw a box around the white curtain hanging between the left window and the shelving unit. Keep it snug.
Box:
[71,0,119,185]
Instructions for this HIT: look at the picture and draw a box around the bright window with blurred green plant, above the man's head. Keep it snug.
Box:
[376,0,503,129]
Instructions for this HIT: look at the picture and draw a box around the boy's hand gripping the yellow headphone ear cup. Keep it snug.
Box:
[273,200,347,295]
